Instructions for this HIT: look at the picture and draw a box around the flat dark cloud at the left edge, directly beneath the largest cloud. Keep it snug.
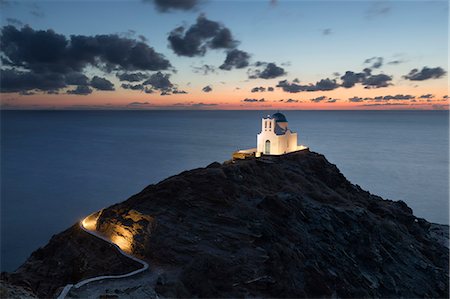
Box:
[0,69,67,92]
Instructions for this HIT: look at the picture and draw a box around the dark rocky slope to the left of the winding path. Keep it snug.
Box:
[1,224,141,298]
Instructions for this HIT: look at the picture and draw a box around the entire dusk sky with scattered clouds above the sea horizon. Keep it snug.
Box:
[0,0,449,110]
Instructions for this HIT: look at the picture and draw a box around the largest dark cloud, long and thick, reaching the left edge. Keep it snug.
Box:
[0,25,171,73]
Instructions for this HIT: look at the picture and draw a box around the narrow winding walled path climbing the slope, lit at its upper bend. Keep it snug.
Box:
[57,220,148,299]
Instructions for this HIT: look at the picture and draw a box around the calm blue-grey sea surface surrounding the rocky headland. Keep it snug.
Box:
[0,111,449,271]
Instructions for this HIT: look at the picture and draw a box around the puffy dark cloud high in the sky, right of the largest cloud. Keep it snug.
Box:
[167,14,238,57]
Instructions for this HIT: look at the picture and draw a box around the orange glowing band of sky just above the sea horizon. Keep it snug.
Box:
[1,82,449,110]
